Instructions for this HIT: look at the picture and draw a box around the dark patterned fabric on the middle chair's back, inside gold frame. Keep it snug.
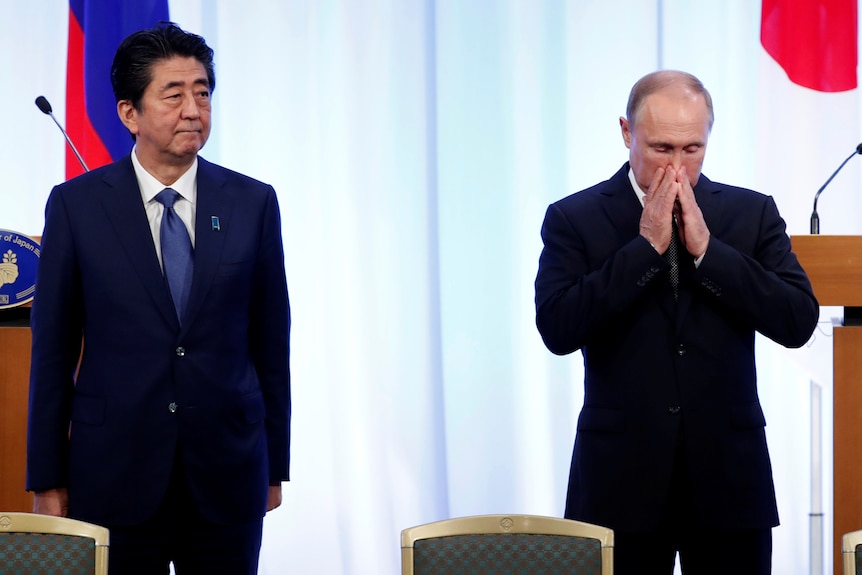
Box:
[413,533,602,575]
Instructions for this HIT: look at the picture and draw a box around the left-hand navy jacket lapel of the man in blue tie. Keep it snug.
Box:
[101,156,177,325]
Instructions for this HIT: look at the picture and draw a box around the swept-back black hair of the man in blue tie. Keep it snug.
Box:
[111,22,215,111]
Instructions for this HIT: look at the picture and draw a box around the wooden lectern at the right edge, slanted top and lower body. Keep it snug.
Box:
[792,235,862,573]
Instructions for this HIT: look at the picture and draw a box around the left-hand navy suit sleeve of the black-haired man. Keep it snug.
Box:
[27,188,83,491]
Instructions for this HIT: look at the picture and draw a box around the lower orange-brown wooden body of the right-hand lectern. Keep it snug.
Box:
[832,325,862,573]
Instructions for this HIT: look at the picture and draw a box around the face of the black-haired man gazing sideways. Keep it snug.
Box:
[118,57,210,165]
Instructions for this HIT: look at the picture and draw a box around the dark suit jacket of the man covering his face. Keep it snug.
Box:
[536,164,819,531]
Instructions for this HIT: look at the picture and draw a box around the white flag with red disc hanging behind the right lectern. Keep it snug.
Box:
[756,0,862,235]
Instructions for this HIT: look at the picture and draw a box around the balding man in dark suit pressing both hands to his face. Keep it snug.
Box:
[536,71,819,575]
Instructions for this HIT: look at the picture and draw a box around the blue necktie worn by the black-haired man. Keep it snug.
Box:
[156,188,194,320]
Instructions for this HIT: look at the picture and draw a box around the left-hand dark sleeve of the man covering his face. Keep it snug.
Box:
[535,204,670,355]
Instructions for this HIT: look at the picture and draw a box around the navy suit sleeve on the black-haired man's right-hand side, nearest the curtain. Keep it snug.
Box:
[250,187,291,485]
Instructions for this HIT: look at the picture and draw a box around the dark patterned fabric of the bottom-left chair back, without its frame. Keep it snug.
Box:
[0,533,96,575]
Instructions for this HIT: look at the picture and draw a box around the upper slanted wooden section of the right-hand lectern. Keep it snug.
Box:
[791,236,862,307]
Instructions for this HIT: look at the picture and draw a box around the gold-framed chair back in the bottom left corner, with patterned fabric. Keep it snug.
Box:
[0,512,108,575]
